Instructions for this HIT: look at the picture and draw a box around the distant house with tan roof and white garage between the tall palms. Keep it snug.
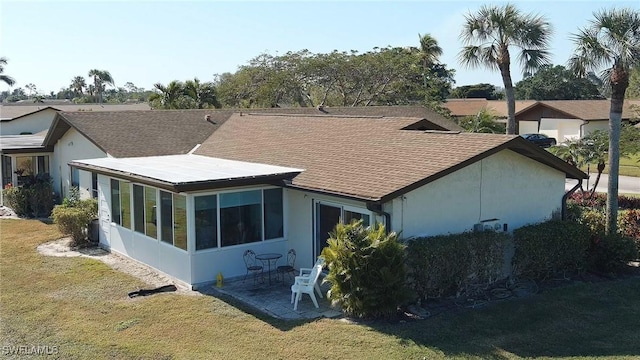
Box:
[516,100,640,143]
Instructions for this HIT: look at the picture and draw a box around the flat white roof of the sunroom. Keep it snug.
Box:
[69,154,304,192]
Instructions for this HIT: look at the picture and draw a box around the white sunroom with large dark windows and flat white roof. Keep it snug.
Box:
[70,155,303,285]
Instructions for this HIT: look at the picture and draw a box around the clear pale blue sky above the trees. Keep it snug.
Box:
[0,0,640,94]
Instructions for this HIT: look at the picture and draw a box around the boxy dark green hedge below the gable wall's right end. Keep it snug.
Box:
[513,221,591,280]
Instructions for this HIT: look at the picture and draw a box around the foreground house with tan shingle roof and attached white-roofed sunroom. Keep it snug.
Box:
[69,113,587,286]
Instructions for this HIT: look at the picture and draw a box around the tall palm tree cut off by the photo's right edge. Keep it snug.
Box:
[569,9,640,234]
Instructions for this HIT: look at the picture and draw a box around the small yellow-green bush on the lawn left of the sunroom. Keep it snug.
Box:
[52,199,98,246]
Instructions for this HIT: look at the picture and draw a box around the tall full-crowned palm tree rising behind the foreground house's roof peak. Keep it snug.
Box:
[458,4,552,134]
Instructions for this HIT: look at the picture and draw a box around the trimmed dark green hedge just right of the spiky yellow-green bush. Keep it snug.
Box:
[407,231,509,300]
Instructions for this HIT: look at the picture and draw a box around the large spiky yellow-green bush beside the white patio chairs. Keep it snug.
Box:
[322,220,409,317]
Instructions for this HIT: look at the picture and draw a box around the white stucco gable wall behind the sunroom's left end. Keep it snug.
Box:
[51,128,107,198]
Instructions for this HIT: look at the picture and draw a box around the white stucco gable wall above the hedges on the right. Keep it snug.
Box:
[391,150,565,238]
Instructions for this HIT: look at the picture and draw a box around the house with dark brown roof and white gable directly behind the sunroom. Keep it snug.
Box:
[43,110,231,197]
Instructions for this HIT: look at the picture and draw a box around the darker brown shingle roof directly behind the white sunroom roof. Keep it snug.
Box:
[45,110,231,157]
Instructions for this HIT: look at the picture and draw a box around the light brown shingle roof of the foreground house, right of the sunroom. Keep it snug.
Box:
[196,114,586,200]
